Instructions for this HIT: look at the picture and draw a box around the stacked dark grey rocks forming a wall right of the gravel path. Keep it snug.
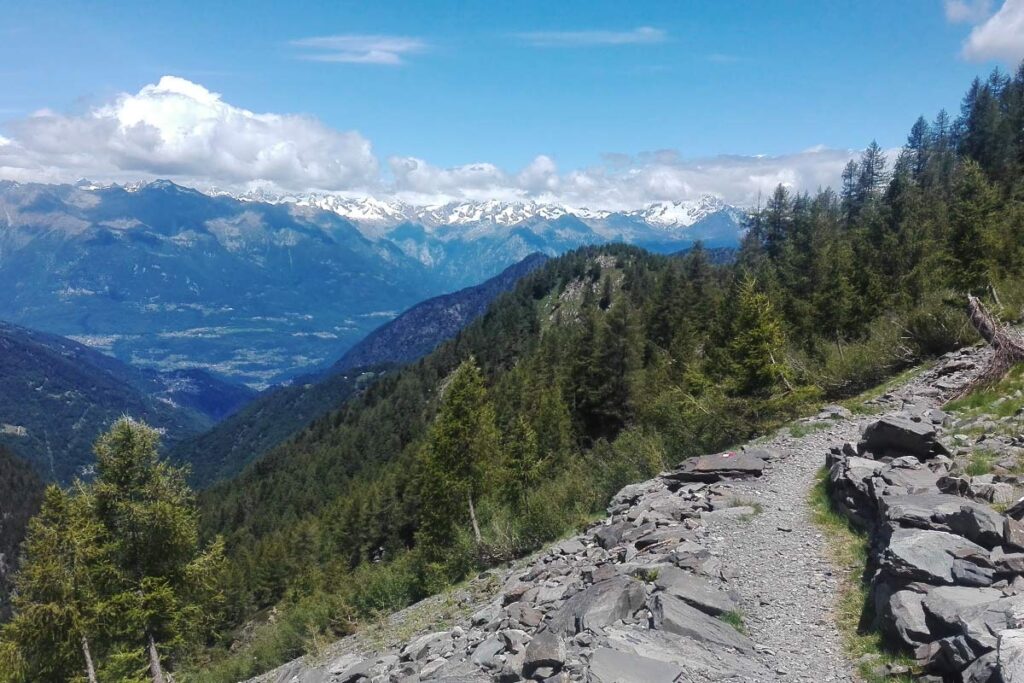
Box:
[826,352,1024,683]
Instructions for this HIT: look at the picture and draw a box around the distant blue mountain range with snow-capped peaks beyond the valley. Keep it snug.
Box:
[0,180,742,389]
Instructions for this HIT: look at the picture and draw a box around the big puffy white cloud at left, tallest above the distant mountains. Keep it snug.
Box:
[0,76,379,189]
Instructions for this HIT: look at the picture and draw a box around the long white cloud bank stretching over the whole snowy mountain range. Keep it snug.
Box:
[0,76,854,209]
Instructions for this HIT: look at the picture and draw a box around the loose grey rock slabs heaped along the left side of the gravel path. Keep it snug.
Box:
[258,450,775,683]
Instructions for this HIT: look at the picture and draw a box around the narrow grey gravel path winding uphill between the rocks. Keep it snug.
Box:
[708,349,987,682]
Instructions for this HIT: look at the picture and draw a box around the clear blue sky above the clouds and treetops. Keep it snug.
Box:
[0,0,1024,205]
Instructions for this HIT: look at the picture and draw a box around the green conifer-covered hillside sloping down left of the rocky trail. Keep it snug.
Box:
[186,65,1024,674]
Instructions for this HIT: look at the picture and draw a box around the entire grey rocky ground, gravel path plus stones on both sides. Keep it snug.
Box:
[247,349,1024,683]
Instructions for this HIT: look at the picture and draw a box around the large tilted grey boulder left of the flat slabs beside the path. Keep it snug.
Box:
[549,577,647,635]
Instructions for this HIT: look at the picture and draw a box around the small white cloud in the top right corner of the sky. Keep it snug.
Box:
[946,0,1024,66]
